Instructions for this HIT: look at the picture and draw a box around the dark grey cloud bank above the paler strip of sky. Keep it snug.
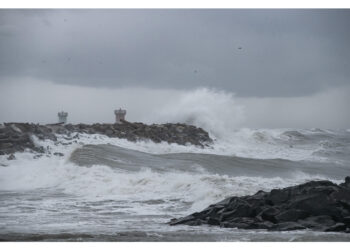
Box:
[0,9,350,127]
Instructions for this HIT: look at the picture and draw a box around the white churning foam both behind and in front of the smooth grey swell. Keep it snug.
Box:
[0,113,344,213]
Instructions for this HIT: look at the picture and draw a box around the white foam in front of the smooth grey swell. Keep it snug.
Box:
[0,148,336,213]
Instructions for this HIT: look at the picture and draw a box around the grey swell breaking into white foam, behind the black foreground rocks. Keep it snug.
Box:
[0,145,342,214]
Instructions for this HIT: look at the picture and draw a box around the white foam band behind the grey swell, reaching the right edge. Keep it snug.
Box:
[0,128,350,173]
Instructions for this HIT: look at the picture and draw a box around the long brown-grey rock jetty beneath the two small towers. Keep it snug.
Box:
[0,121,212,155]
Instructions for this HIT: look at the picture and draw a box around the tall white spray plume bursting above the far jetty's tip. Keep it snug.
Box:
[154,88,244,138]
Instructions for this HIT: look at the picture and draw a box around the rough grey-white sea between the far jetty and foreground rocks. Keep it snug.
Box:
[0,128,350,242]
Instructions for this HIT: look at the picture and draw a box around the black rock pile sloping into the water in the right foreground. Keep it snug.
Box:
[169,176,350,233]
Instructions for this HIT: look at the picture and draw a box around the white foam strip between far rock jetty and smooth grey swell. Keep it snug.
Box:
[30,128,336,161]
